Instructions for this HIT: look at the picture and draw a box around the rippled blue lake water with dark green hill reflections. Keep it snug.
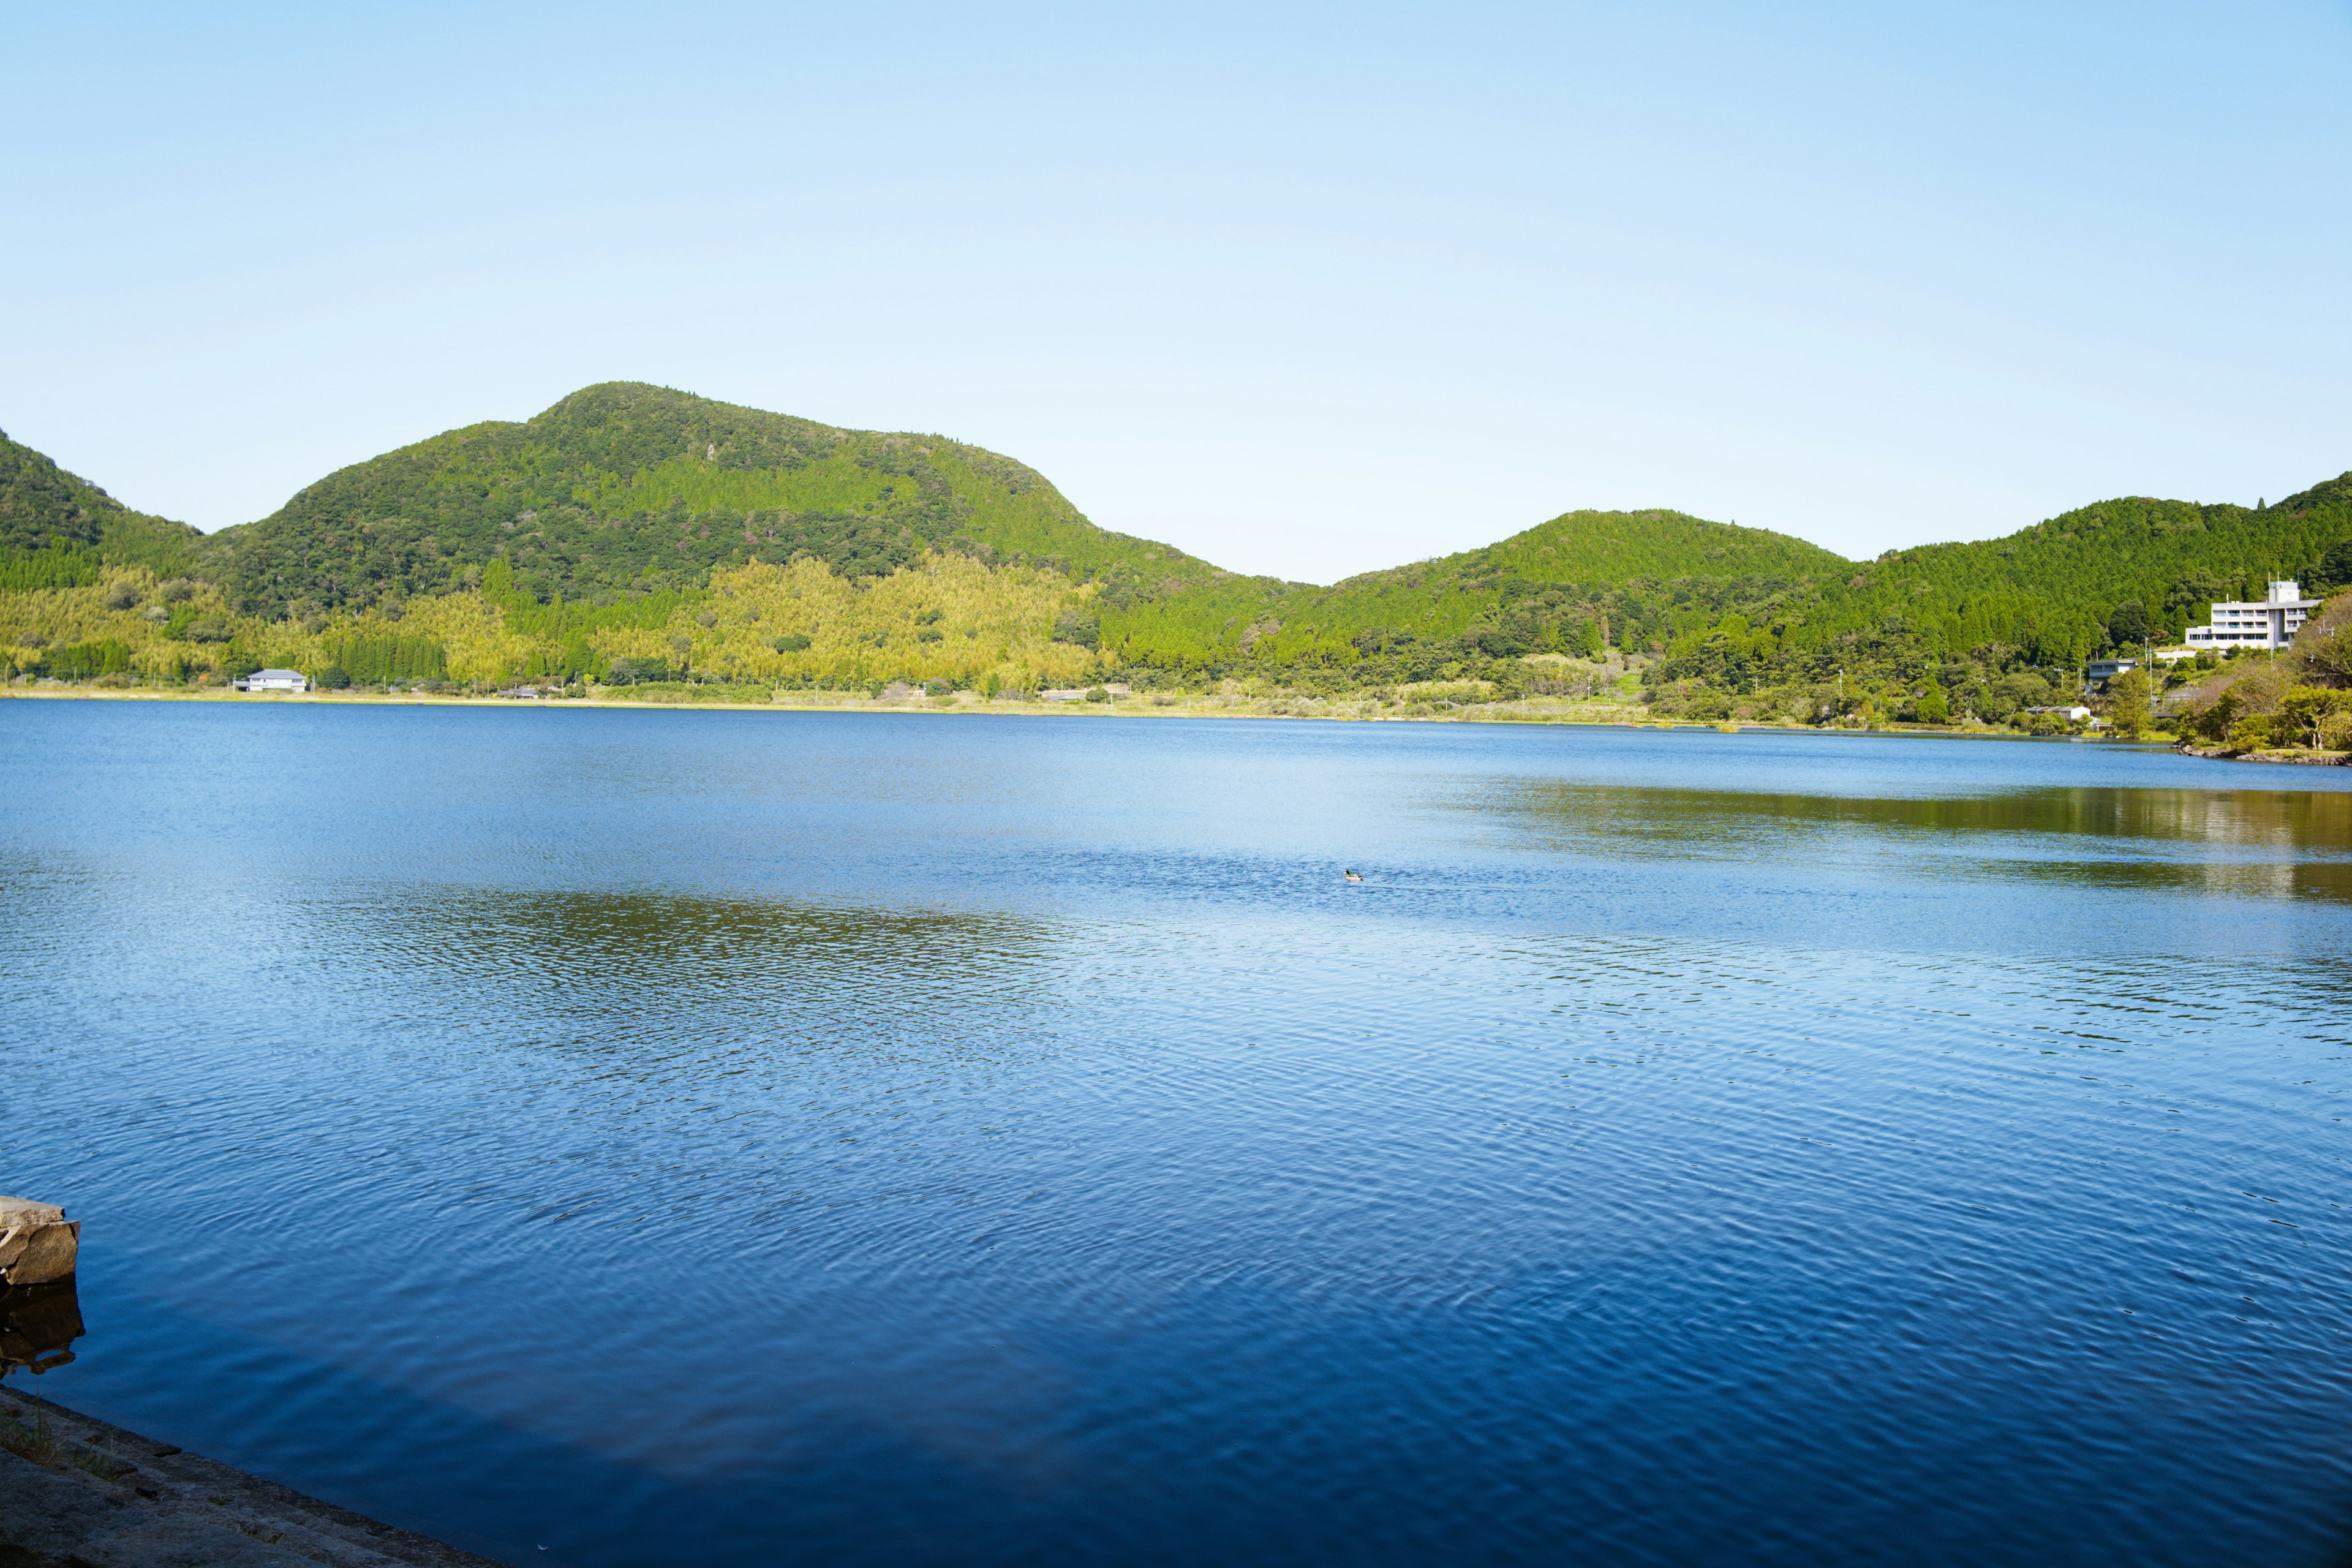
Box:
[0,701,2352,1566]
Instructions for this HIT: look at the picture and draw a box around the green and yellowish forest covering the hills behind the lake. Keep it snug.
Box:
[0,383,2352,719]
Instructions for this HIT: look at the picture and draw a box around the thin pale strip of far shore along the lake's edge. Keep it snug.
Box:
[0,687,2305,766]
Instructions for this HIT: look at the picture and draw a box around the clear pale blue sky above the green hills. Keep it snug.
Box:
[0,0,2352,581]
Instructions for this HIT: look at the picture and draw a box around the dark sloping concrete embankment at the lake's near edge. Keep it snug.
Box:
[0,1389,499,1568]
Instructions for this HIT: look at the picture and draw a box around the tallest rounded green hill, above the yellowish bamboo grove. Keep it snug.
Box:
[207,381,1251,616]
